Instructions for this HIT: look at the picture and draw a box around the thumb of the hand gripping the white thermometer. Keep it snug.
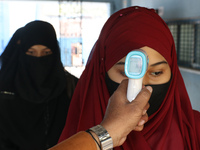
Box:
[132,86,153,109]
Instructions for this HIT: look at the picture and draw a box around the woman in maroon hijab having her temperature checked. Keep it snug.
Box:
[59,7,200,150]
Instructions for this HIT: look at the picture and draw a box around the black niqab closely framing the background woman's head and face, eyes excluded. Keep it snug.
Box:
[15,21,66,103]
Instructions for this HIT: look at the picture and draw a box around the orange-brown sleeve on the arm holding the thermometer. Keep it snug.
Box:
[49,131,97,150]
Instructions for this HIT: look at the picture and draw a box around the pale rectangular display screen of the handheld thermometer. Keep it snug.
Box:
[128,55,142,75]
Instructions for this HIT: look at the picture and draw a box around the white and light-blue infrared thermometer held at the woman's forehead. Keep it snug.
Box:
[124,49,149,102]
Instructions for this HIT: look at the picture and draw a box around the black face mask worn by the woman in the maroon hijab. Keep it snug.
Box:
[105,73,172,116]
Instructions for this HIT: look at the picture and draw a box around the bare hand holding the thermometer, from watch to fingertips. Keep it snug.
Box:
[101,79,152,147]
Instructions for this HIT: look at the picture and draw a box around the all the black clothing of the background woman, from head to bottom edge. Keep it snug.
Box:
[0,21,78,150]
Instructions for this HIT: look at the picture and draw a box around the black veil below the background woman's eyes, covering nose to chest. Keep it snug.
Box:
[15,55,61,103]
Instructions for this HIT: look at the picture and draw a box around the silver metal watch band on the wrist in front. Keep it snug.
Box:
[90,125,113,150]
